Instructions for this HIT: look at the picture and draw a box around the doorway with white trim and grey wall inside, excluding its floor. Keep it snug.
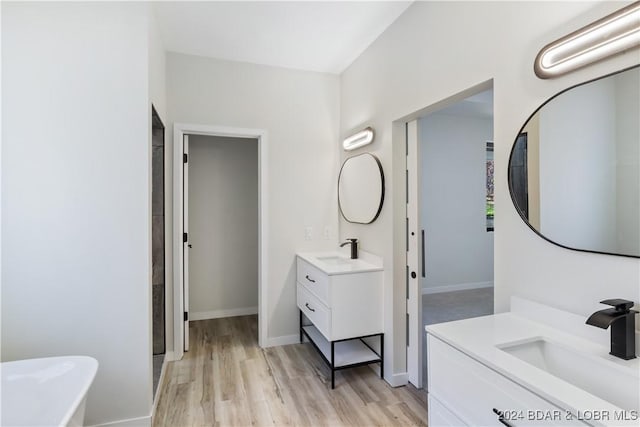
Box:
[174,123,267,359]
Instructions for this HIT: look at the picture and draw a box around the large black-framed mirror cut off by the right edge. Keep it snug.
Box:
[508,66,640,258]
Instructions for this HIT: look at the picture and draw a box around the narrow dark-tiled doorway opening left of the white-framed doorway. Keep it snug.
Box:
[151,106,166,398]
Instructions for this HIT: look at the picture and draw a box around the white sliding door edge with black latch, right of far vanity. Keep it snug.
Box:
[406,120,425,388]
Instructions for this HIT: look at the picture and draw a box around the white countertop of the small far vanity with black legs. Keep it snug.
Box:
[297,251,383,276]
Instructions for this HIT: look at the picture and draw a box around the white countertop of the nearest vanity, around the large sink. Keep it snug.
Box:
[425,313,640,426]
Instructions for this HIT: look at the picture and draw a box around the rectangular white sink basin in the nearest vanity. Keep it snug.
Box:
[497,337,640,411]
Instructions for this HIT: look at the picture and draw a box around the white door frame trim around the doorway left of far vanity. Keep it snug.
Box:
[173,123,268,360]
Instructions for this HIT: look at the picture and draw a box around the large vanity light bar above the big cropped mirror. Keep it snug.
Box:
[533,1,640,79]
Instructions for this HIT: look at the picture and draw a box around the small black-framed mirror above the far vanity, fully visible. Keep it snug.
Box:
[338,153,384,224]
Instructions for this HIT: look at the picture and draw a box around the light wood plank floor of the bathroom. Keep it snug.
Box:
[153,316,427,427]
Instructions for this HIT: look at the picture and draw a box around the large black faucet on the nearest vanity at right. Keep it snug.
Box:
[587,299,638,360]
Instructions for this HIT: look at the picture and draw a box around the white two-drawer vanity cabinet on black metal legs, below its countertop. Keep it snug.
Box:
[296,256,384,388]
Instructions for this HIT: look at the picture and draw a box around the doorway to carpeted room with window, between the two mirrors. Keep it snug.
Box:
[406,85,494,388]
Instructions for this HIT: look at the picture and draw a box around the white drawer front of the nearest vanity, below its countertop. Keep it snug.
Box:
[427,335,585,427]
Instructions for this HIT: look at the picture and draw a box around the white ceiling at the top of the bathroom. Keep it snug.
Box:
[154,1,411,74]
